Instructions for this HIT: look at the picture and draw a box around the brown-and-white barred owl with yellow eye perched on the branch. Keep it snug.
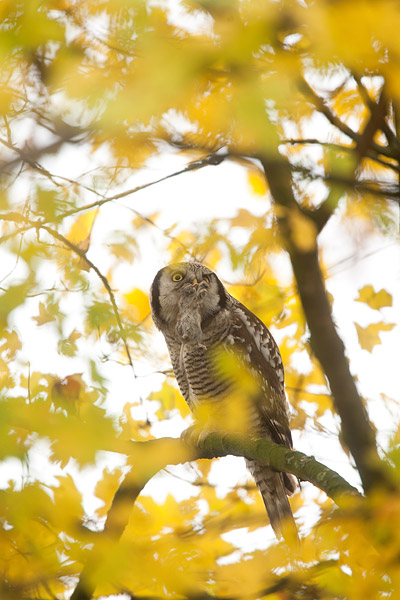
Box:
[150,262,297,538]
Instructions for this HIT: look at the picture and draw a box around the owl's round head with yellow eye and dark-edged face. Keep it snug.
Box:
[150,262,228,331]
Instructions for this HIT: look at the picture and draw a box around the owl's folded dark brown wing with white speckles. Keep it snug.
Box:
[231,300,293,448]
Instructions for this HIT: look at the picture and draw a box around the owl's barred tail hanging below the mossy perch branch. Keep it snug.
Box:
[246,460,299,544]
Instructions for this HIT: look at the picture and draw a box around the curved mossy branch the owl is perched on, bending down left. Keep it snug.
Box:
[71,434,360,600]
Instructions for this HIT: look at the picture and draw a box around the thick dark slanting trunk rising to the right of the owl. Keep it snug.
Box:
[260,157,388,491]
